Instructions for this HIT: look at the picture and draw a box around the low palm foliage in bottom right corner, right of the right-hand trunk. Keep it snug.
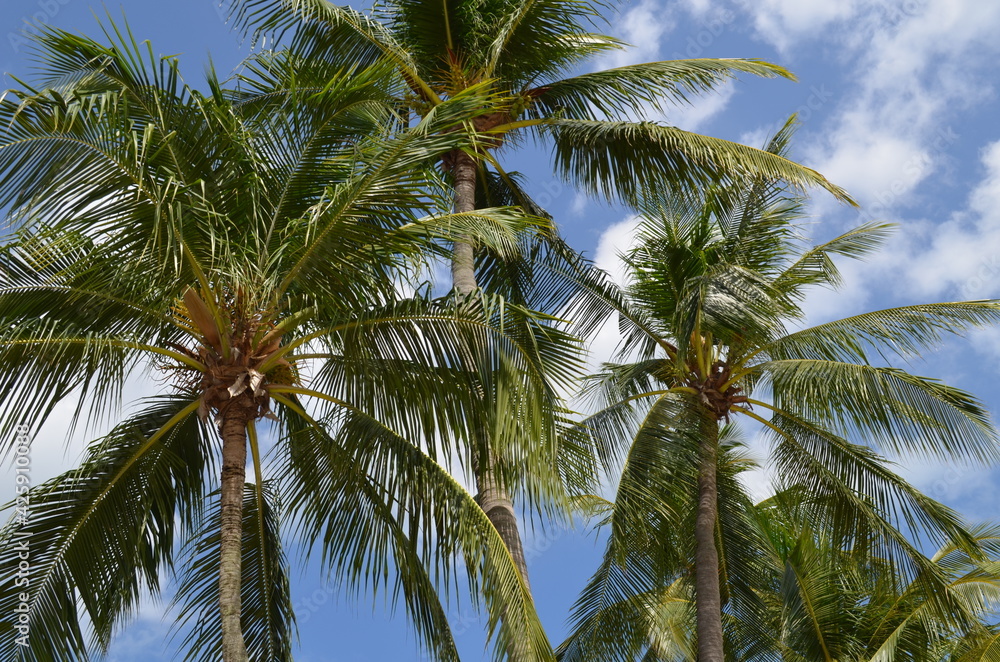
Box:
[752,490,1000,662]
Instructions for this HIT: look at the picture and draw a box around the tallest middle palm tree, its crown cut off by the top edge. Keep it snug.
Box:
[232,0,849,580]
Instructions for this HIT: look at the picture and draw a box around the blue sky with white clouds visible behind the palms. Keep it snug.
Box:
[0,0,1000,662]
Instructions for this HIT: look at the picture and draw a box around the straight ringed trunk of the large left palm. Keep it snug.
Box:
[219,394,252,662]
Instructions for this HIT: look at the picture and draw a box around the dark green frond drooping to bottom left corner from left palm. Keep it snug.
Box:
[0,394,212,660]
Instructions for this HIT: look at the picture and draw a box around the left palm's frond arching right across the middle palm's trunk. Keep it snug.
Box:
[290,295,579,489]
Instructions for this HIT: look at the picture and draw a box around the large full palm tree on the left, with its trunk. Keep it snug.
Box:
[0,22,566,662]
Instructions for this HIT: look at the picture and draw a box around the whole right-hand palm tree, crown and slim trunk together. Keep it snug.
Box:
[567,122,1000,662]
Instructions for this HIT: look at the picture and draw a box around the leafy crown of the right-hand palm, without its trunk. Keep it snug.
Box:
[563,123,1000,660]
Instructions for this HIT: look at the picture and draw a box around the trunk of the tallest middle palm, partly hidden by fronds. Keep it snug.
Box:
[451,151,530,588]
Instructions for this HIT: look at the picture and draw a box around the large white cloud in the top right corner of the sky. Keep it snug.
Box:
[796,0,1000,215]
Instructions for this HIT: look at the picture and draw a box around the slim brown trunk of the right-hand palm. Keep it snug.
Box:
[695,415,725,662]
